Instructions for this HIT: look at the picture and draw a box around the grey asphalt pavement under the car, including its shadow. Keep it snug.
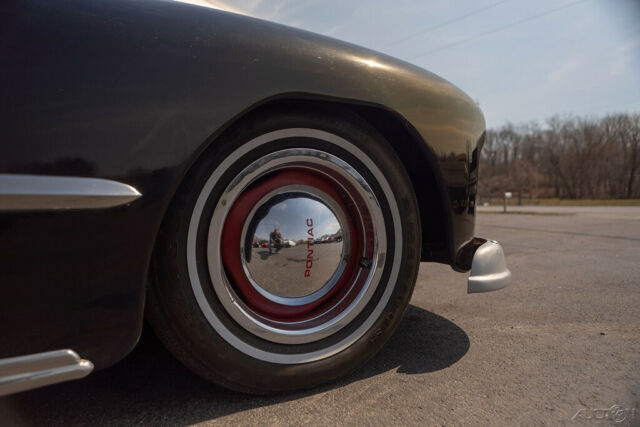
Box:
[0,207,640,426]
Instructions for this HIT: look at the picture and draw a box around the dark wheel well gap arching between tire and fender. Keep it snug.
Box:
[204,94,452,264]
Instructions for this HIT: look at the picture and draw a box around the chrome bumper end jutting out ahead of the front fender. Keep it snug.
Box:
[467,240,511,294]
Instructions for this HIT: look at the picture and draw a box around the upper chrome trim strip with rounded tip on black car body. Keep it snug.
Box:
[0,174,141,211]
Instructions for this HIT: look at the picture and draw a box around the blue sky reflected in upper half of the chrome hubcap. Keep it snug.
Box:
[256,197,340,241]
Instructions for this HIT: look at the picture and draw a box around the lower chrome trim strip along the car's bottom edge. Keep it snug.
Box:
[0,350,93,396]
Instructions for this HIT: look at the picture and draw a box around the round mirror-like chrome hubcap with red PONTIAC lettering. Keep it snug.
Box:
[241,185,349,305]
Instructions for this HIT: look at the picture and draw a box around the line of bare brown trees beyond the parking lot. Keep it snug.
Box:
[479,113,640,199]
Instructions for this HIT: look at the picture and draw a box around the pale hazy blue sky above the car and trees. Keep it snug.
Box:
[179,0,640,128]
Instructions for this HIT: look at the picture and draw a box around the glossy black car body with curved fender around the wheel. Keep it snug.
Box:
[0,0,510,396]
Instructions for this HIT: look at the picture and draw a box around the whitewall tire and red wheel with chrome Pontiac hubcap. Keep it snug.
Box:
[147,109,421,393]
